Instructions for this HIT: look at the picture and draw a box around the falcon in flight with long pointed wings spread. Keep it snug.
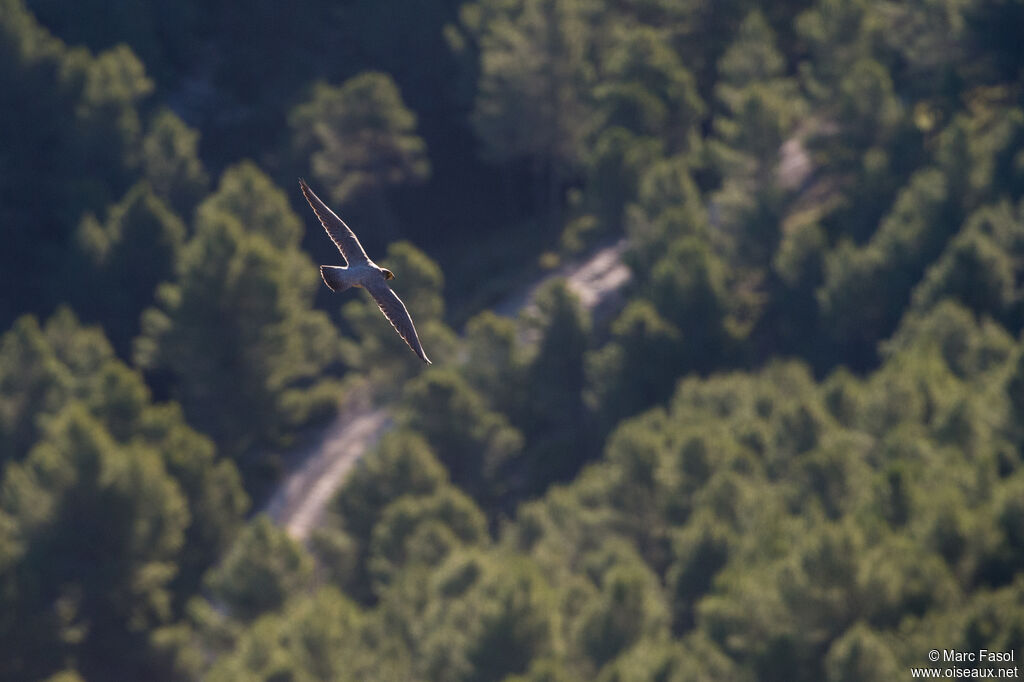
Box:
[299,178,431,365]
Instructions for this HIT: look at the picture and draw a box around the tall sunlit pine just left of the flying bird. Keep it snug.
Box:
[135,163,338,479]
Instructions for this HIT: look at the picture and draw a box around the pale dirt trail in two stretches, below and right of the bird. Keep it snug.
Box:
[263,240,630,542]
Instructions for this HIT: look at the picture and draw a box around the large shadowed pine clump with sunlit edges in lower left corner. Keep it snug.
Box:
[0,308,248,679]
